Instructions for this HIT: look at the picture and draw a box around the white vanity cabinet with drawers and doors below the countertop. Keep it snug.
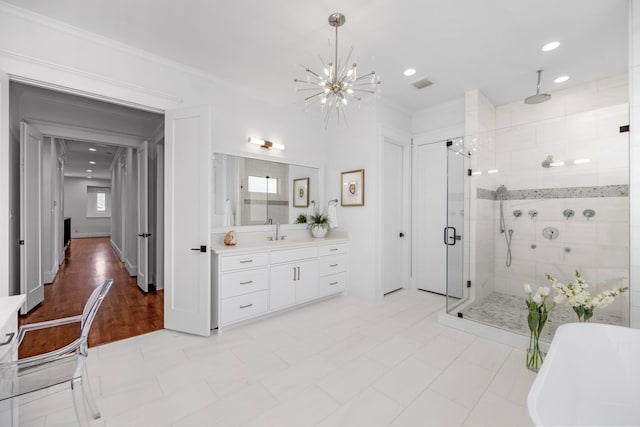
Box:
[211,239,348,332]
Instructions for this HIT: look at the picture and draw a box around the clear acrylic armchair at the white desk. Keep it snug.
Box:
[0,279,113,426]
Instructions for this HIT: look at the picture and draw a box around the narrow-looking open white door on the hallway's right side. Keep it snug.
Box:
[136,141,151,292]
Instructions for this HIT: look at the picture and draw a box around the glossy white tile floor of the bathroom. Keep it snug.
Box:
[19,291,534,427]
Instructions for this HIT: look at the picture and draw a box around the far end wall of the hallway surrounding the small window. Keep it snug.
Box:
[64,177,111,238]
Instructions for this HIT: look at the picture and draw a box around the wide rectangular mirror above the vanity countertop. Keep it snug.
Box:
[212,153,320,229]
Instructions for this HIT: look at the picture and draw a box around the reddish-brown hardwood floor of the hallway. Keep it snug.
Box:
[19,237,164,357]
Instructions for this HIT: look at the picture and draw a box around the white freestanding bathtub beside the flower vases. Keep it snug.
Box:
[522,323,640,426]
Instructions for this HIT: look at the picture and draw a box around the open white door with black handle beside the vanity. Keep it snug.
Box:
[164,107,212,336]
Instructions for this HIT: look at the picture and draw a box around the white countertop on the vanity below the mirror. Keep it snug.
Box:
[211,232,349,255]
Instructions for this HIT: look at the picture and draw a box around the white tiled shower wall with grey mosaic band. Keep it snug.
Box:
[468,75,629,319]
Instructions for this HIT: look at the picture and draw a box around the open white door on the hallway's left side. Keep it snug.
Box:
[20,122,44,314]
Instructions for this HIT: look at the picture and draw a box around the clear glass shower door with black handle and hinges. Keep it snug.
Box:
[444,138,469,312]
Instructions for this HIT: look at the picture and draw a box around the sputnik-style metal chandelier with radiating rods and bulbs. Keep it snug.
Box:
[293,13,380,128]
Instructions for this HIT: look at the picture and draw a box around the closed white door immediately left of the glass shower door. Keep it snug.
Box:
[413,141,447,295]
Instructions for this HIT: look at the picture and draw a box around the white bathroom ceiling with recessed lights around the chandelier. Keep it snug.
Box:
[2,0,628,112]
